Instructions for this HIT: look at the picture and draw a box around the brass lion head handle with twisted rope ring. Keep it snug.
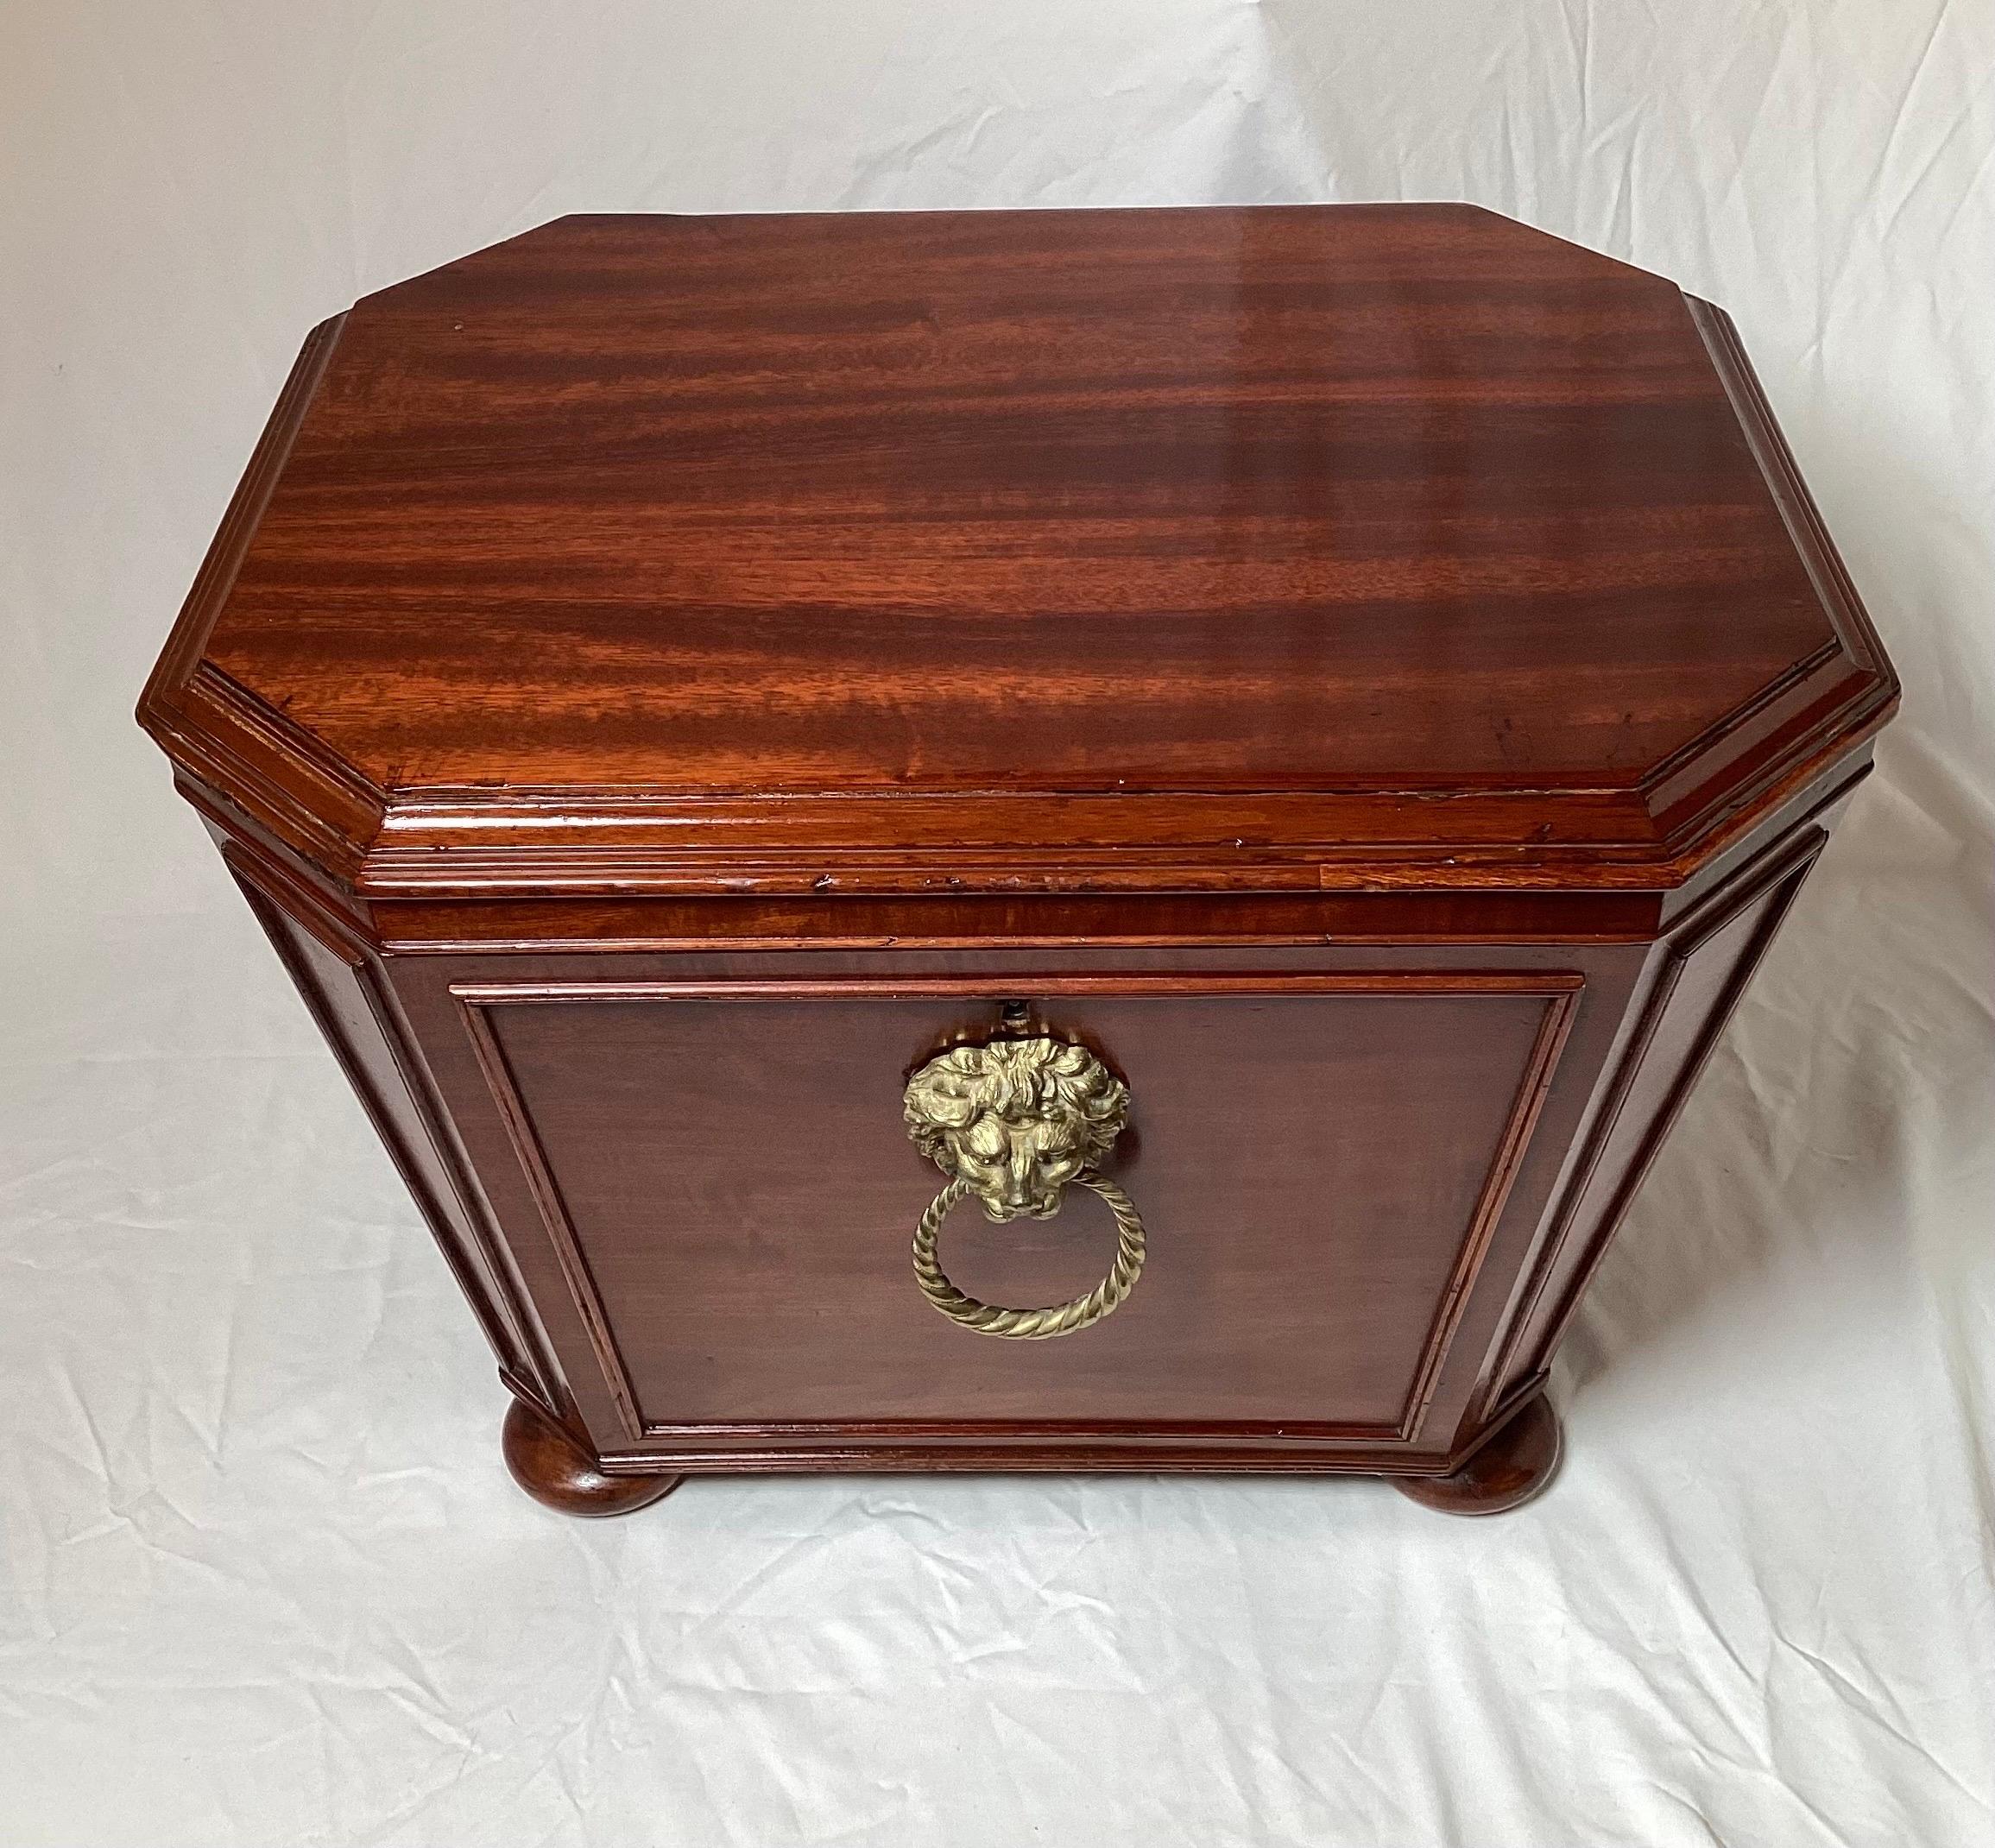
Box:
[904,1038,1143,1341]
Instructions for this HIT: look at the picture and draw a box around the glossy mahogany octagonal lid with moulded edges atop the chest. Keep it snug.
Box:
[142,205,1893,888]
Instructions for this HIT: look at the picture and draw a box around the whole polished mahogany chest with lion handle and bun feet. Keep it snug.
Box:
[140,205,1897,1513]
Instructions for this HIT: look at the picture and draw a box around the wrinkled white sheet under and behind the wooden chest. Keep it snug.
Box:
[0,0,1995,1848]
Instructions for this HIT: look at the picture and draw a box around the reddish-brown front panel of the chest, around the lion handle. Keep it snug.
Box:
[401,952,1619,1465]
